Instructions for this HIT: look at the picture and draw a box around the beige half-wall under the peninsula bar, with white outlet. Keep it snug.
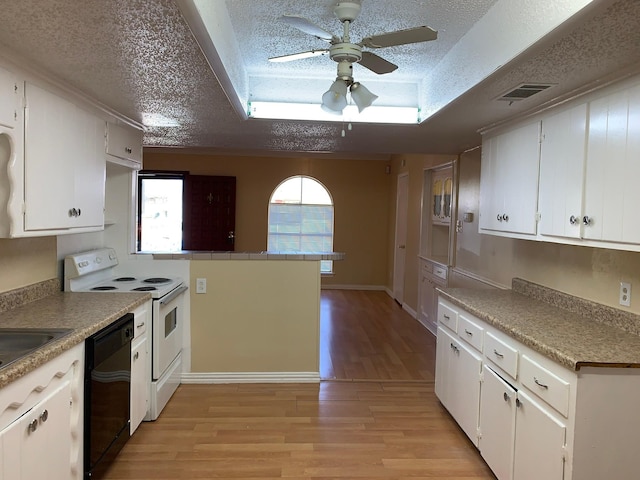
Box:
[190,260,320,373]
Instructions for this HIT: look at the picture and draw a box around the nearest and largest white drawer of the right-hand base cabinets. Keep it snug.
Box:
[520,355,569,417]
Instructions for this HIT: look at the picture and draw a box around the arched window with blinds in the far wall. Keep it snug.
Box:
[267,175,333,273]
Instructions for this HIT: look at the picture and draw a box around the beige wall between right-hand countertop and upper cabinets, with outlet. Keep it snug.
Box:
[456,149,640,313]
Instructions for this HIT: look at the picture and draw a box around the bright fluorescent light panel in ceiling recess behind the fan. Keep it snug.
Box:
[248,102,418,124]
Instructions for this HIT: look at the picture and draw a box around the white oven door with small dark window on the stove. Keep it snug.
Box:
[151,286,187,380]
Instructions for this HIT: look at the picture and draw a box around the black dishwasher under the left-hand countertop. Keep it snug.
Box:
[84,313,133,480]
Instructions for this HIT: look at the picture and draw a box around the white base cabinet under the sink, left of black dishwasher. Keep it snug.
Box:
[0,344,84,480]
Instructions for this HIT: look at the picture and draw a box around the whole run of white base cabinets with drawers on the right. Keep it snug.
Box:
[435,297,640,480]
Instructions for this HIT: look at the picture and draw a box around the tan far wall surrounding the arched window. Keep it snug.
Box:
[144,152,395,287]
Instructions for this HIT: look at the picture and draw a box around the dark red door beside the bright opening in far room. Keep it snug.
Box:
[182,175,236,251]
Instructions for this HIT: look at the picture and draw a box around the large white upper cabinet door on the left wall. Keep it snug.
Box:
[24,83,106,233]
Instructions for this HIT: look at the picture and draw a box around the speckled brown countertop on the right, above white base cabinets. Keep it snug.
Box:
[438,279,640,370]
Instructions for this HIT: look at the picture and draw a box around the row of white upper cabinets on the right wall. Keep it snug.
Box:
[480,77,640,251]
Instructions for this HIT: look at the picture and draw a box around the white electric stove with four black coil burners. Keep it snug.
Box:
[64,248,187,420]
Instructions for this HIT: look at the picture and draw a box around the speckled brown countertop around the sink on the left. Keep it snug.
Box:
[0,292,151,388]
